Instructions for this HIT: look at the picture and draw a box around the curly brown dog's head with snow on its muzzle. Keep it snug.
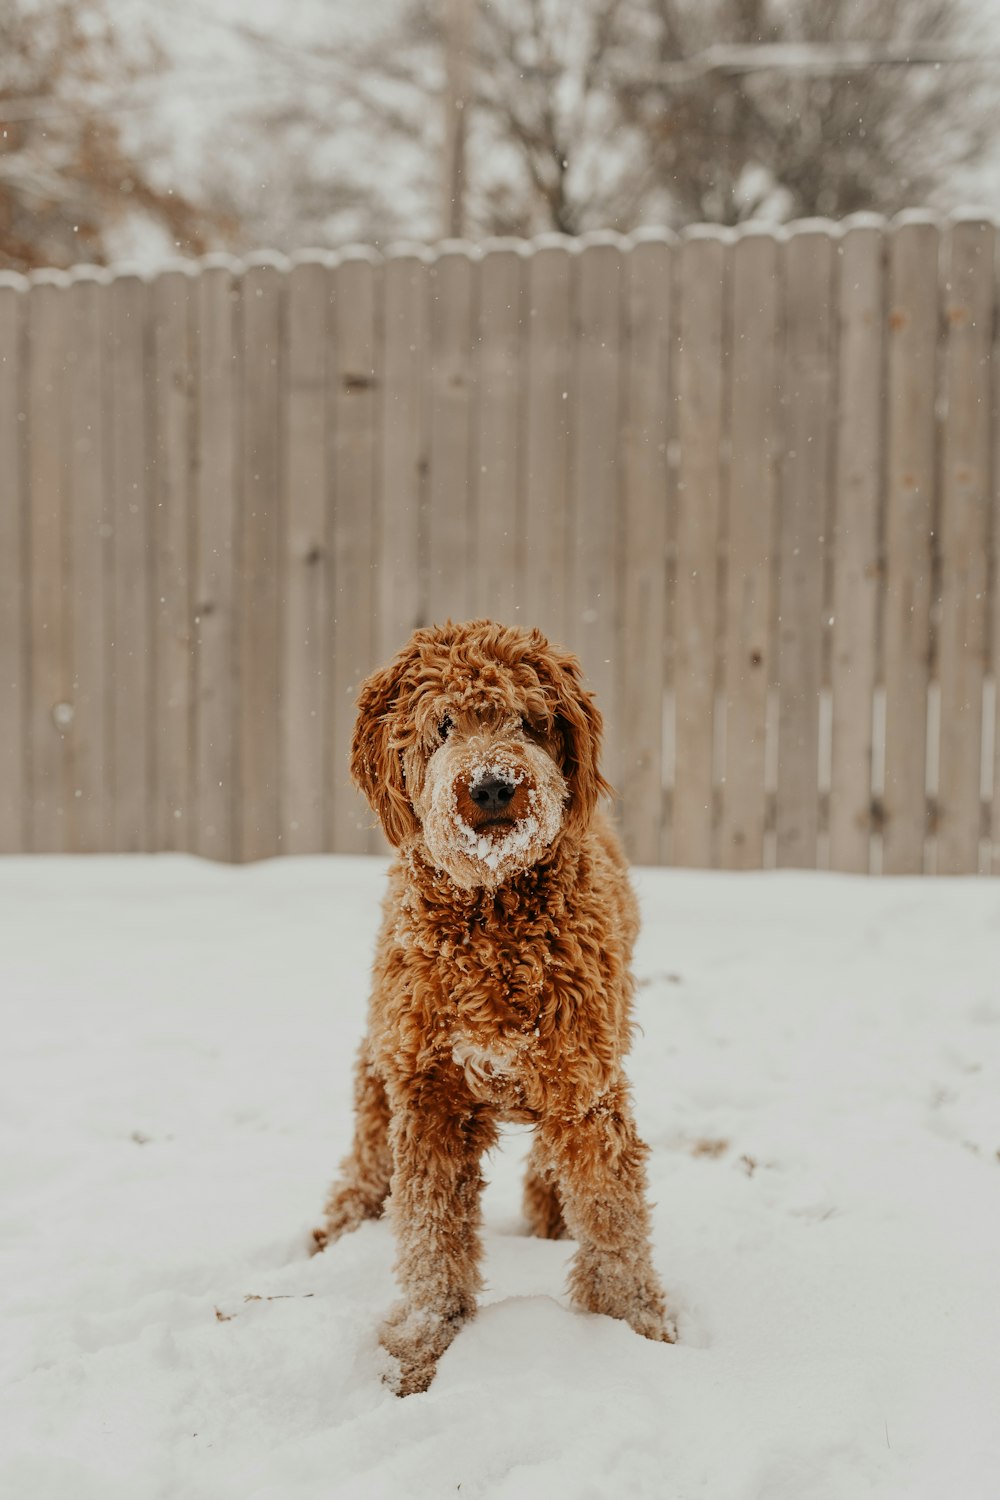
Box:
[351,620,610,890]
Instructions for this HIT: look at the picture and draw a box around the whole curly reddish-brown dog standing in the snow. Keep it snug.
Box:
[315,620,673,1395]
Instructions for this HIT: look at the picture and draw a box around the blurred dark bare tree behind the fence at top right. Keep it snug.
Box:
[615,0,994,224]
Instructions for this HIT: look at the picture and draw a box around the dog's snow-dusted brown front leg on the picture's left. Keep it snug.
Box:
[379,1082,496,1397]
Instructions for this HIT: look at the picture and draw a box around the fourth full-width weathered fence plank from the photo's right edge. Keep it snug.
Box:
[777,224,835,869]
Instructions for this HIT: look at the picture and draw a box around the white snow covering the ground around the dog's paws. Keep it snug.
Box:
[0,857,1000,1500]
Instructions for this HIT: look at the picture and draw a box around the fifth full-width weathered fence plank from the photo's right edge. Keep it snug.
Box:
[720,230,781,870]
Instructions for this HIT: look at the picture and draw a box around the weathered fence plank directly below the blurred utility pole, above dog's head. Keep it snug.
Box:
[427,243,483,624]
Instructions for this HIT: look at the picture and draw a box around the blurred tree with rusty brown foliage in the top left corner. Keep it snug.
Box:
[0,0,217,270]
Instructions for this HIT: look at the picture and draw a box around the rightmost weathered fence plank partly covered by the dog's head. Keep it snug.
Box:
[568,234,622,788]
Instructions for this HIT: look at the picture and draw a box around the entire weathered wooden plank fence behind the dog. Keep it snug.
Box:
[0,215,1000,873]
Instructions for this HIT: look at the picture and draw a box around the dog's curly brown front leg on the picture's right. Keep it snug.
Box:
[541,1083,675,1343]
